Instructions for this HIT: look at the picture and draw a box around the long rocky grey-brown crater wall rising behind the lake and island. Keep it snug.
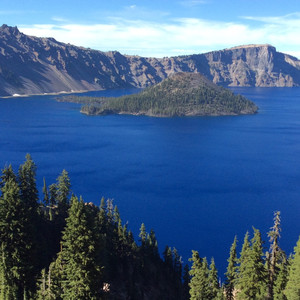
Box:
[0,25,300,96]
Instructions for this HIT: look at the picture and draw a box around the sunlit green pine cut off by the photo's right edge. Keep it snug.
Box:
[284,237,300,300]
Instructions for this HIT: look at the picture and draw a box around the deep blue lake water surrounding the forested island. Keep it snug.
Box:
[0,88,300,273]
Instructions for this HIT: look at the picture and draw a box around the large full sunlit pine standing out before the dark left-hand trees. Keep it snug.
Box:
[61,197,101,300]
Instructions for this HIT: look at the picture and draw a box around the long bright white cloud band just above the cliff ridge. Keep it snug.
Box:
[20,14,300,57]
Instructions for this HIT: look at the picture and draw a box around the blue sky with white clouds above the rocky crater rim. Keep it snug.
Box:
[0,0,300,58]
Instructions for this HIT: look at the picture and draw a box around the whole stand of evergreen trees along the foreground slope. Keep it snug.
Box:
[0,154,300,300]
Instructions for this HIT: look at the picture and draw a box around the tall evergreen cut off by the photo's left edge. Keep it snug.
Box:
[0,177,35,300]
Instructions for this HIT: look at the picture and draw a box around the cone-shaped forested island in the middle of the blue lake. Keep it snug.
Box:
[58,73,258,117]
